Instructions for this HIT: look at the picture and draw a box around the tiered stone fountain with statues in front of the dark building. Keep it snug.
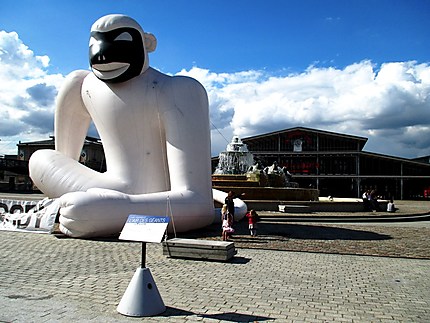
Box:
[212,136,319,210]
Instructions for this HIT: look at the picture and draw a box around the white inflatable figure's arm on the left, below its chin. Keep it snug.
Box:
[54,70,91,160]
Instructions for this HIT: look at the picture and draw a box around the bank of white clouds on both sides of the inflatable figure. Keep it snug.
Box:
[0,31,430,162]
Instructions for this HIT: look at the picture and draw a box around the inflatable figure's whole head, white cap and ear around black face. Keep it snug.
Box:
[89,15,157,83]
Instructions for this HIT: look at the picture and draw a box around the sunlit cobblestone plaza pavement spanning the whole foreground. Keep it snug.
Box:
[0,197,430,322]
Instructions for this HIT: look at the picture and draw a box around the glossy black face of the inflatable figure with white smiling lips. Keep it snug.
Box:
[89,27,145,83]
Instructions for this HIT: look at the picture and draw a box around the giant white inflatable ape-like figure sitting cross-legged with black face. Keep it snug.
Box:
[29,15,246,237]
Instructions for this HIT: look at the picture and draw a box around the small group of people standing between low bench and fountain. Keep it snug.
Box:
[221,191,259,241]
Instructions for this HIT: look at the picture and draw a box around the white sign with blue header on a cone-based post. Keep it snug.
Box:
[117,214,169,317]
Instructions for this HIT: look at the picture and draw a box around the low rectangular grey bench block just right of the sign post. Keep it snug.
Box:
[163,238,237,261]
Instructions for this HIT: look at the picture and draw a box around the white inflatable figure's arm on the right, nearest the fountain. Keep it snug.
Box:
[164,76,212,193]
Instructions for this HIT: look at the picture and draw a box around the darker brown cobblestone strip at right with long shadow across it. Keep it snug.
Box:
[187,222,430,259]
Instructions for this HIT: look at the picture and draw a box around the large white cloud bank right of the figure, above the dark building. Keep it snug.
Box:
[181,60,430,157]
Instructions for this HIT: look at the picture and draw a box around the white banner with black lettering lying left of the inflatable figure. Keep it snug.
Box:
[0,198,59,233]
